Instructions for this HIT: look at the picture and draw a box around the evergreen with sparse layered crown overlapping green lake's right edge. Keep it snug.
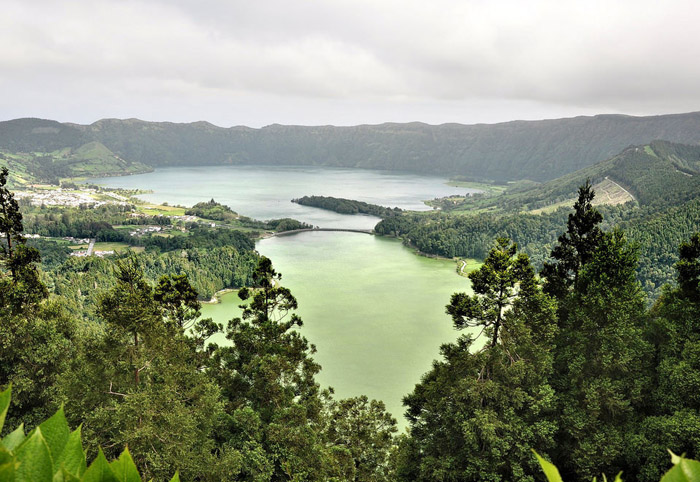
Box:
[396,240,557,481]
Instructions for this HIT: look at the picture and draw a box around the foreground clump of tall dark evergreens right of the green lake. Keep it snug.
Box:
[397,186,700,482]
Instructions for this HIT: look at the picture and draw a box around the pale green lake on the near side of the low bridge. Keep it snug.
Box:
[202,232,469,424]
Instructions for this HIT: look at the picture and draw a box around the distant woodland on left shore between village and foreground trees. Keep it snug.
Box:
[20,202,318,306]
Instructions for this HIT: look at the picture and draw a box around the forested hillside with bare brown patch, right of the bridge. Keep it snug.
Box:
[375,141,700,298]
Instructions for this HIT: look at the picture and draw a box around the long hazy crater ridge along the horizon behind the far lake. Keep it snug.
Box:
[0,113,700,181]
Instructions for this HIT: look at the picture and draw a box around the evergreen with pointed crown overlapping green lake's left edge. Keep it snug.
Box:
[206,257,353,481]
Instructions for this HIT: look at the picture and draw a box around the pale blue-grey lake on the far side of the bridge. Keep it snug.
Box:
[91,166,475,229]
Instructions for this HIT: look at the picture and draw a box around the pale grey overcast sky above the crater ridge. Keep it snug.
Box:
[0,0,700,127]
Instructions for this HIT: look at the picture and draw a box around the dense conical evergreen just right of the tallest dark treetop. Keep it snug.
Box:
[553,231,652,480]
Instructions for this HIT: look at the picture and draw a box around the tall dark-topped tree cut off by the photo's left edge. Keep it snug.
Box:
[0,168,76,427]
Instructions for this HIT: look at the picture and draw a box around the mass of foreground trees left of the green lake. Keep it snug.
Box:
[0,170,396,481]
